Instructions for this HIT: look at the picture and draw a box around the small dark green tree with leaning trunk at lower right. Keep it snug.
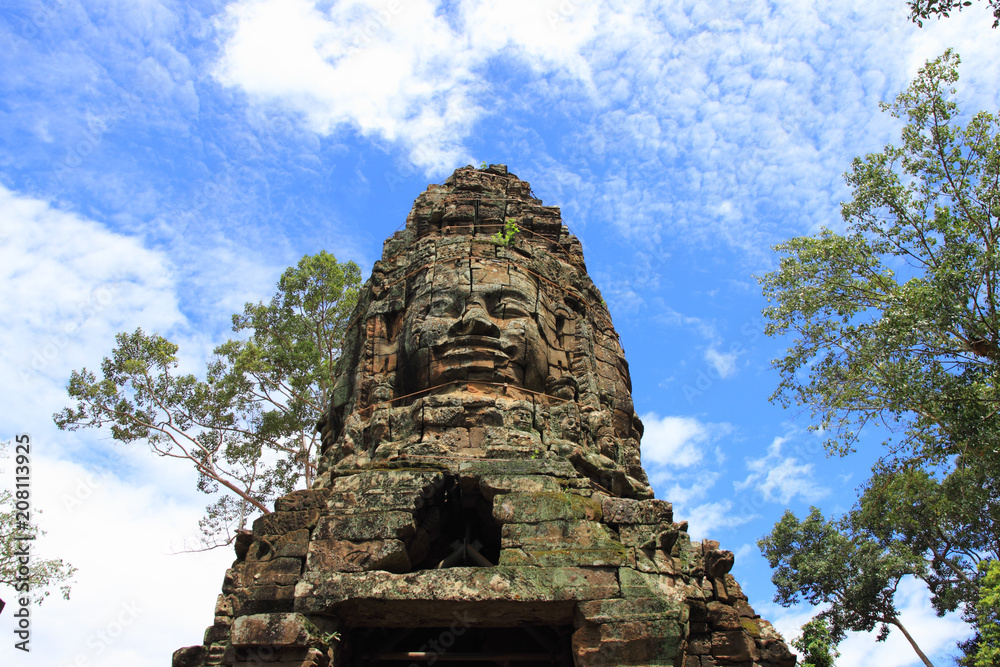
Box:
[757,507,931,666]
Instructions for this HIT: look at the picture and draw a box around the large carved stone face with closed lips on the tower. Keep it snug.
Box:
[398,260,550,394]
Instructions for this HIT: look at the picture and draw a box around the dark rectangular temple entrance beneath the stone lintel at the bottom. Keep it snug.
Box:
[343,622,573,667]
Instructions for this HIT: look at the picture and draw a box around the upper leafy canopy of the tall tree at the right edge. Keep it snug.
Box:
[760,50,1000,470]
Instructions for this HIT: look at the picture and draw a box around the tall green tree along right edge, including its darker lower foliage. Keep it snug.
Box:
[760,50,1000,664]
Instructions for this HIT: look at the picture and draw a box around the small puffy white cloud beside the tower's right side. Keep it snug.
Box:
[641,412,732,468]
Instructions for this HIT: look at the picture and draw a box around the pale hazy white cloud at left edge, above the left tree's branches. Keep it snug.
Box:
[0,186,185,394]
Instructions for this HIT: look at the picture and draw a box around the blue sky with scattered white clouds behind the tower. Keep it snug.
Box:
[0,0,1000,667]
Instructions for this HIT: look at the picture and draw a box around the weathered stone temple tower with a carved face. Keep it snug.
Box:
[173,165,795,667]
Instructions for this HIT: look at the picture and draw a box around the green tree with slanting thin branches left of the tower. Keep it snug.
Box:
[54,252,361,548]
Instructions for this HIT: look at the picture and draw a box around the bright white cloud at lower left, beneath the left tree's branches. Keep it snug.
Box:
[0,452,233,667]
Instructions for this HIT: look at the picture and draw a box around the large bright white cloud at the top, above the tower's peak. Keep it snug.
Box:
[215,0,598,172]
